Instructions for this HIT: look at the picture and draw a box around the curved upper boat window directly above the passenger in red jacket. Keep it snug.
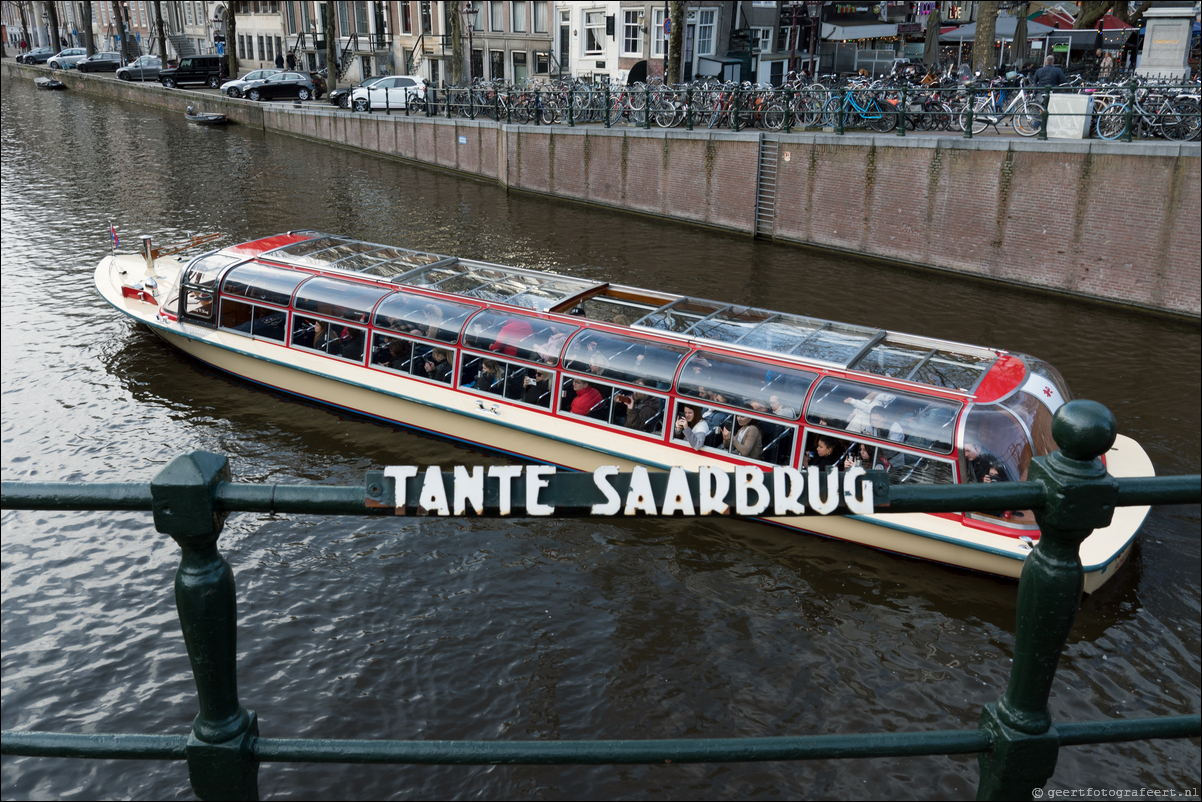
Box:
[564,329,686,390]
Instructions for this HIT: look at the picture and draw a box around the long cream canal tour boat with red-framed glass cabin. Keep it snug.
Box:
[95,231,1153,592]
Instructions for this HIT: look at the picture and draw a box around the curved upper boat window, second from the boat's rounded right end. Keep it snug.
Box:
[677,352,817,421]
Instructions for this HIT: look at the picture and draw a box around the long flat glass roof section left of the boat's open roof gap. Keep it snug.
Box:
[263,234,603,311]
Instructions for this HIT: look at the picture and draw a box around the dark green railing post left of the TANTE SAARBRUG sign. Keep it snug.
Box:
[150,451,258,800]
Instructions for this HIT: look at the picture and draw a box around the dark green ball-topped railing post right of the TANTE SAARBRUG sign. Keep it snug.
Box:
[977,400,1118,800]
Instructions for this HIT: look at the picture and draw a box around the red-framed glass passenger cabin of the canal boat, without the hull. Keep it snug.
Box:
[162,231,1071,536]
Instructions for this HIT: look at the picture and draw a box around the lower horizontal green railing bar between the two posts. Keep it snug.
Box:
[252,730,993,766]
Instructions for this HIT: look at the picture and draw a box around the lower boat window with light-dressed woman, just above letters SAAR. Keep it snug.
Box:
[672,402,797,465]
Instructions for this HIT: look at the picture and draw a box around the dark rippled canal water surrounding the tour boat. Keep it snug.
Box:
[0,78,1202,800]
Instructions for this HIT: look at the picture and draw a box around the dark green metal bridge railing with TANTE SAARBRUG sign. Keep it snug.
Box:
[0,400,1202,800]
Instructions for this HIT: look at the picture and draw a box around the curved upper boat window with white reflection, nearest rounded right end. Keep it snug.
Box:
[805,376,962,453]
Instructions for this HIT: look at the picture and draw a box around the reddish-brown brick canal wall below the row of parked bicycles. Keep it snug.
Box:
[2,60,1202,317]
